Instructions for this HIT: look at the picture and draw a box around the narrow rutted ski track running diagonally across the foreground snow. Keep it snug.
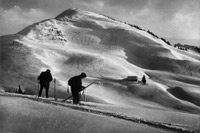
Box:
[0,92,197,133]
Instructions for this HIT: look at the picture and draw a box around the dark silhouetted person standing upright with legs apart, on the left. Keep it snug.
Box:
[38,69,53,98]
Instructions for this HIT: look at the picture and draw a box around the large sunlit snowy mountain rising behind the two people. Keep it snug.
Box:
[0,9,200,114]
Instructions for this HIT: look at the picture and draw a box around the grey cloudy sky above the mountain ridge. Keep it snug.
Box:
[0,0,200,39]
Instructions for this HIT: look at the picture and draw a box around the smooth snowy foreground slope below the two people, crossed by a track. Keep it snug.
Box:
[0,93,200,133]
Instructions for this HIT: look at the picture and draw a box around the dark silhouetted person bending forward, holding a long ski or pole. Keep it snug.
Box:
[68,73,87,104]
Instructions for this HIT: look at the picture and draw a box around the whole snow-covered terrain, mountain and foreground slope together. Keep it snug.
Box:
[0,9,200,133]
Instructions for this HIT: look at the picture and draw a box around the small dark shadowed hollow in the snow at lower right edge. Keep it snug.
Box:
[167,87,200,107]
